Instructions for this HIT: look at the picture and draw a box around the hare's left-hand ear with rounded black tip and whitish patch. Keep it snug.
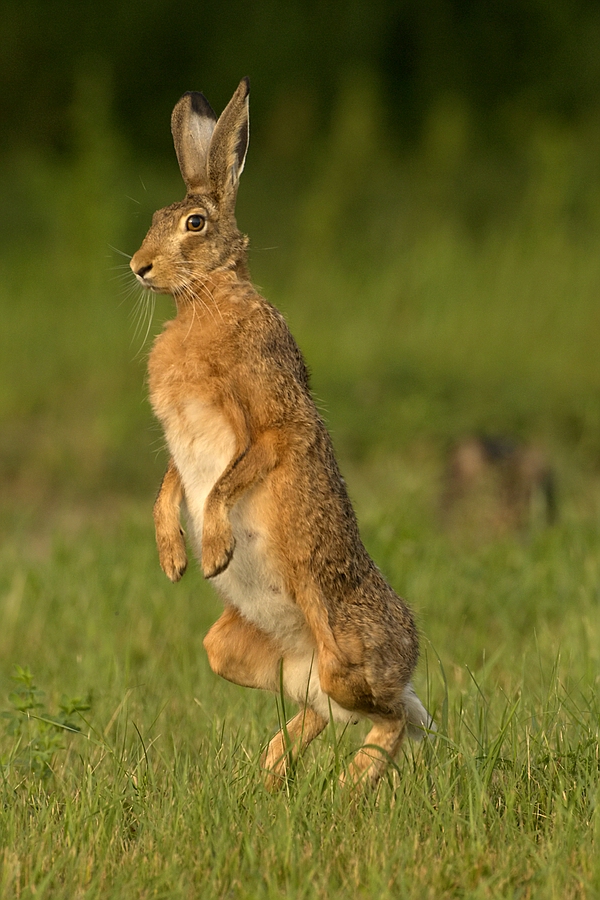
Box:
[171,91,217,194]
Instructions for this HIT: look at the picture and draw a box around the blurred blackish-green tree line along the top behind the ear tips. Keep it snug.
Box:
[0,0,600,160]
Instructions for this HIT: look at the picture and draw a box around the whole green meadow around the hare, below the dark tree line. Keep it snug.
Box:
[0,86,600,900]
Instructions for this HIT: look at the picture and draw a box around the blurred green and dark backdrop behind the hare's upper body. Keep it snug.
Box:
[0,0,600,517]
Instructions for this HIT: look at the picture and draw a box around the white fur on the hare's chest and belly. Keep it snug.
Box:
[163,400,356,722]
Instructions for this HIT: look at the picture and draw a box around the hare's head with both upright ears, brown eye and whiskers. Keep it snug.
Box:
[130,78,250,296]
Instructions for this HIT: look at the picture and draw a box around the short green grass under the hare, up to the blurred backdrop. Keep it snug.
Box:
[0,478,600,898]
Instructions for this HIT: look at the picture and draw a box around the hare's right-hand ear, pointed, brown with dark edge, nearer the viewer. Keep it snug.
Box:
[208,78,250,203]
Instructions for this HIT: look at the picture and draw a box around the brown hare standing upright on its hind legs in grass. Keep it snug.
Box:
[131,78,433,787]
